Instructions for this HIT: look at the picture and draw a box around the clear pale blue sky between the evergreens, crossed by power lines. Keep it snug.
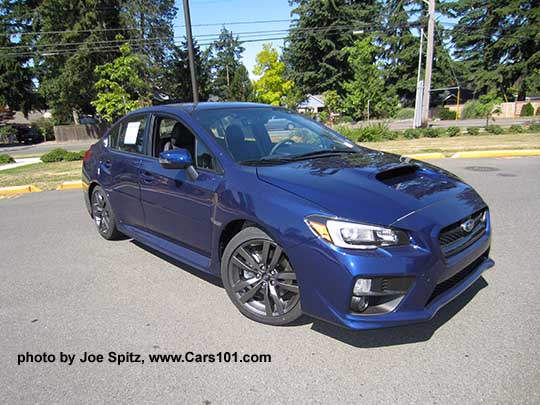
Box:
[174,0,291,78]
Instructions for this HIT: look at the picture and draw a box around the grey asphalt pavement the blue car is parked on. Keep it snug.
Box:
[0,157,540,404]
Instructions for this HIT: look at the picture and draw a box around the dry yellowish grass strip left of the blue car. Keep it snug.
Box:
[0,160,82,190]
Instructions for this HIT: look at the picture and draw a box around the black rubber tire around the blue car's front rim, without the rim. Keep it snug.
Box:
[221,227,302,325]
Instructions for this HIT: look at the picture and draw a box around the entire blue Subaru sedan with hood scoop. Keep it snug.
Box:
[83,103,494,329]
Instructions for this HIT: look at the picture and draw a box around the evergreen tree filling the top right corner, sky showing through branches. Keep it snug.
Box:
[446,0,540,100]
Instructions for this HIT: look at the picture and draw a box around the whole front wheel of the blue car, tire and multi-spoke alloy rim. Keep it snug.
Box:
[221,227,302,325]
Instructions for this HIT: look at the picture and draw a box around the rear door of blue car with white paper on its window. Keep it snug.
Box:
[100,114,149,227]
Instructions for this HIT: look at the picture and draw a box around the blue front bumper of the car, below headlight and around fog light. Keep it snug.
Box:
[289,218,494,330]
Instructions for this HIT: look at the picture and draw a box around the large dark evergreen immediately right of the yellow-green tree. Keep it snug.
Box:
[283,0,378,96]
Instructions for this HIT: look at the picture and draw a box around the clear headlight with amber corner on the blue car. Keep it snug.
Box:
[306,216,409,249]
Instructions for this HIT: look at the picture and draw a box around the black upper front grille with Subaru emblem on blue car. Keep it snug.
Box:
[439,208,487,258]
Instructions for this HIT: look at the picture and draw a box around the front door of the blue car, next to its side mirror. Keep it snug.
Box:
[140,115,222,256]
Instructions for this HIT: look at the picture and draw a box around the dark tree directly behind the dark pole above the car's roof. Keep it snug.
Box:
[166,39,211,102]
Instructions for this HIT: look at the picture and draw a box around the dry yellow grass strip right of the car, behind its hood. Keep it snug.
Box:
[360,133,540,156]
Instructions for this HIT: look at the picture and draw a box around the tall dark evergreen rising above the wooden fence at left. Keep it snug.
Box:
[32,0,125,123]
